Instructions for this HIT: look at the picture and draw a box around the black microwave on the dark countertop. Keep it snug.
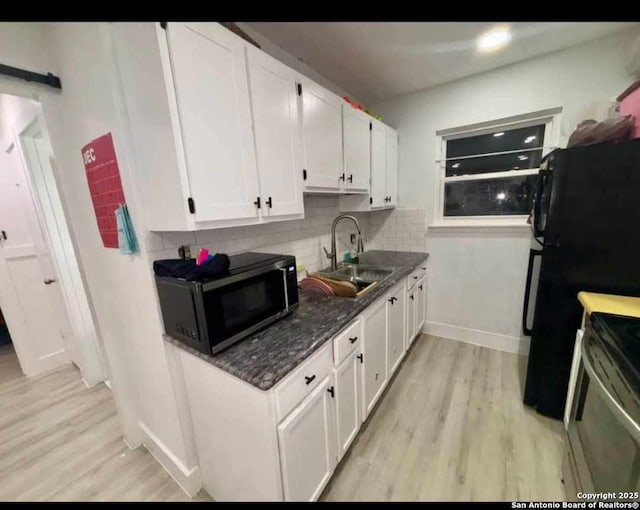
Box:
[156,252,298,354]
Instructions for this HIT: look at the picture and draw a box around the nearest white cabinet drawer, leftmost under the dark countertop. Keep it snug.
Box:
[275,342,333,422]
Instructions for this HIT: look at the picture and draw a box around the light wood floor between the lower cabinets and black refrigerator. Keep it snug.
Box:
[321,335,564,501]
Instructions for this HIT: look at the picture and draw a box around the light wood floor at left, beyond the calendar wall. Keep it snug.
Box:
[0,346,208,501]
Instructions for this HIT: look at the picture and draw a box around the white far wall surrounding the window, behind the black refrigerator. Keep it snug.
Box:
[374,28,638,350]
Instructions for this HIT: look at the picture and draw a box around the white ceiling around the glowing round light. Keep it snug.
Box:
[247,22,640,104]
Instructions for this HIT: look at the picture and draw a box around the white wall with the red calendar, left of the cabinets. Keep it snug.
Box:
[0,23,198,494]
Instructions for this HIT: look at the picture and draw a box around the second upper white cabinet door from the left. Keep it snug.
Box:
[247,45,304,217]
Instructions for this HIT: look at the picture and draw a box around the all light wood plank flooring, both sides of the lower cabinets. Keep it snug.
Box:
[0,336,564,501]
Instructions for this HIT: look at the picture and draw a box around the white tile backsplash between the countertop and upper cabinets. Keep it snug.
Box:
[149,195,426,271]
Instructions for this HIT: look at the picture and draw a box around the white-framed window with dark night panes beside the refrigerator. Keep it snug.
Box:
[435,110,559,225]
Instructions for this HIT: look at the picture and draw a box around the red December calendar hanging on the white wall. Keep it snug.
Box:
[82,133,125,248]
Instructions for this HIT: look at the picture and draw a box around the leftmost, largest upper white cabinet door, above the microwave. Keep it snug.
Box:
[168,23,258,221]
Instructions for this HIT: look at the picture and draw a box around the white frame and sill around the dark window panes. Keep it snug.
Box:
[429,107,562,228]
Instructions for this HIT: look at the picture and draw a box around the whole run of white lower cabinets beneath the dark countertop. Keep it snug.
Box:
[175,260,426,501]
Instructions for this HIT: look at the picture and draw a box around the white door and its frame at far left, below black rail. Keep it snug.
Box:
[0,94,109,386]
